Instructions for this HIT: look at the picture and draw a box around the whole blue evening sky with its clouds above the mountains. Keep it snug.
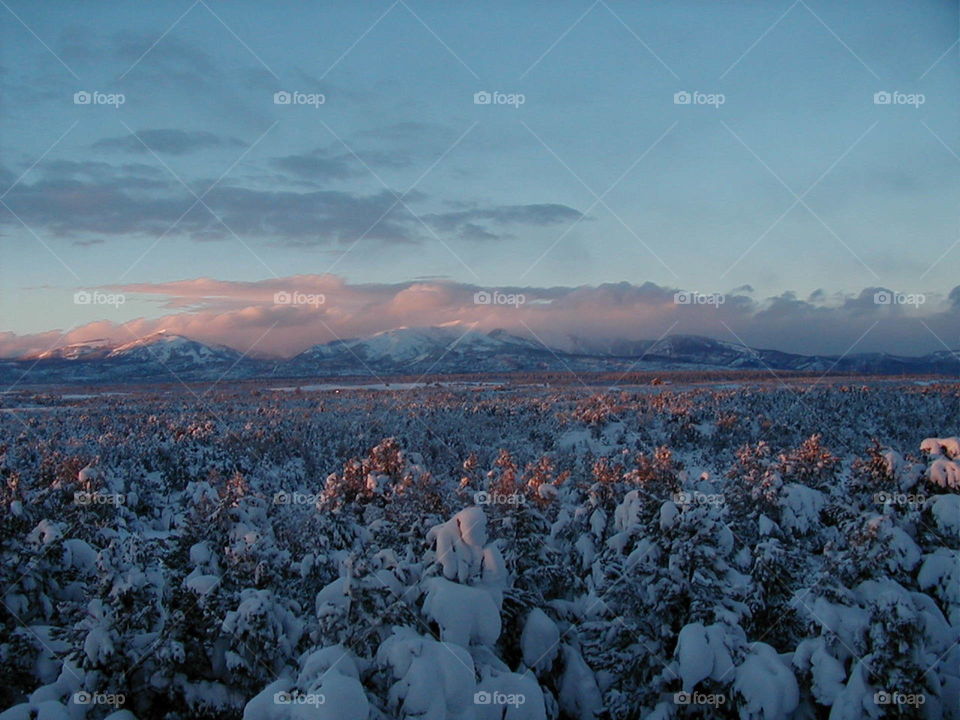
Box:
[0,0,960,356]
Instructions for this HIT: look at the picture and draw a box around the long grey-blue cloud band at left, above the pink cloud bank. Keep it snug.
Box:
[0,156,580,247]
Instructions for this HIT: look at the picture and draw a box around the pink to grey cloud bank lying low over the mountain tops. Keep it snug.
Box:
[0,275,960,357]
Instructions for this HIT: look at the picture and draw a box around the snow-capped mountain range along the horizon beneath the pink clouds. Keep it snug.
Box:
[0,325,960,385]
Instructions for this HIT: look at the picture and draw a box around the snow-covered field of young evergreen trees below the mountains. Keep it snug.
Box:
[0,381,960,720]
